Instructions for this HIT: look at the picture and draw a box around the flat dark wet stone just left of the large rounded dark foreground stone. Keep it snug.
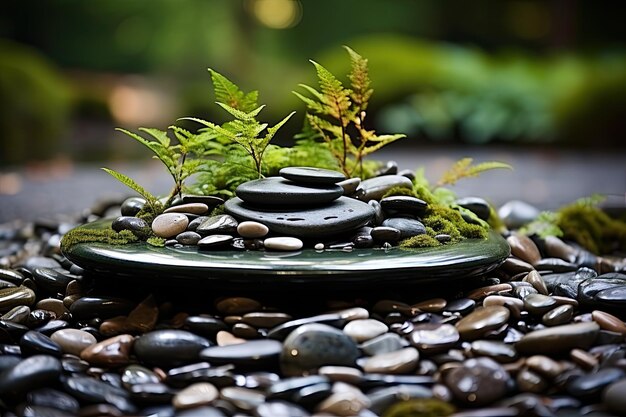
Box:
[200,339,283,369]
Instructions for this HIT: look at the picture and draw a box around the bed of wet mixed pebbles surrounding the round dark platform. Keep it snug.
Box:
[0,197,626,417]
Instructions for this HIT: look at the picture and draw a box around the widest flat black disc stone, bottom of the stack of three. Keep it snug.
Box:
[224,197,374,238]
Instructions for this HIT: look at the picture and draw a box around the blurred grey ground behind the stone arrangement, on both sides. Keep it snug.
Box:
[0,144,626,223]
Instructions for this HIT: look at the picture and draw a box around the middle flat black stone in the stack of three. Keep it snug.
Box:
[235,177,343,207]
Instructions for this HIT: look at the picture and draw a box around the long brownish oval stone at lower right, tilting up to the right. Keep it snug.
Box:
[515,322,600,355]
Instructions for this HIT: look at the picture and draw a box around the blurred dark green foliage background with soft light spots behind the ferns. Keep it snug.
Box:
[0,0,626,164]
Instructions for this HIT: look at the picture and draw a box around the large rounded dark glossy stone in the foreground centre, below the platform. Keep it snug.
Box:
[280,323,359,375]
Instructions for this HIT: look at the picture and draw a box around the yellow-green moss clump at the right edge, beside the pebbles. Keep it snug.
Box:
[557,204,626,255]
